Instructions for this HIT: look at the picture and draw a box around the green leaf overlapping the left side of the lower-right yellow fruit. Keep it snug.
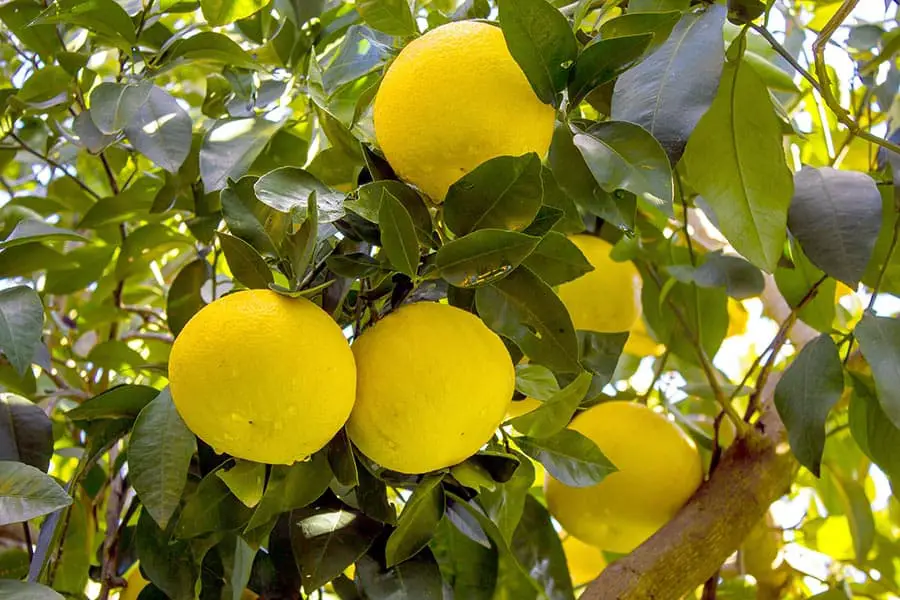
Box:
[515,429,616,487]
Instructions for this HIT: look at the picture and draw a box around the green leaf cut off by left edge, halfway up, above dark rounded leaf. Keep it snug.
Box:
[0,285,44,375]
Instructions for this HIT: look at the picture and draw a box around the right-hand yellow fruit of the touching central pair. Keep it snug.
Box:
[347,302,516,473]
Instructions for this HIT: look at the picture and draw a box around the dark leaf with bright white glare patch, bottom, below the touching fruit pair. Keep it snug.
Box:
[291,505,383,594]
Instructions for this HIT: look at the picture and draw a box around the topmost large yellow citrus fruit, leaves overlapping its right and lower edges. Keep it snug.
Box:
[374,21,555,202]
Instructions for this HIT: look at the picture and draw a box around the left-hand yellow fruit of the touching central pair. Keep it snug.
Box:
[169,290,356,464]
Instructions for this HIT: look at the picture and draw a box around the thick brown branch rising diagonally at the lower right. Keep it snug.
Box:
[581,375,796,600]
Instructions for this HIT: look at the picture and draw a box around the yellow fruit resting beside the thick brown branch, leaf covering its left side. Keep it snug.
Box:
[545,402,703,553]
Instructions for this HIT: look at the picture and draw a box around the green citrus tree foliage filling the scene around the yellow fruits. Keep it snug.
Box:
[0,0,900,600]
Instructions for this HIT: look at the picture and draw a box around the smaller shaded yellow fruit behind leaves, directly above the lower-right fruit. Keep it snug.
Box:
[559,234,641,333]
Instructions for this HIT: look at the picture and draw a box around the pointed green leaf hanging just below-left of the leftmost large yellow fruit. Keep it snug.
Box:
[128,388,197,529]
